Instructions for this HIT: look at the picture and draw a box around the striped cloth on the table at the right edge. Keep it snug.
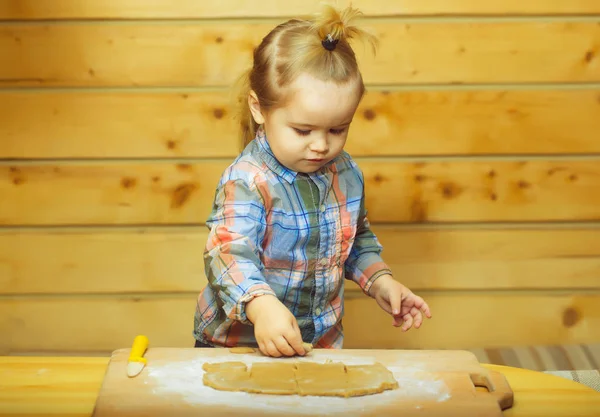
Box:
[468,343,600,392]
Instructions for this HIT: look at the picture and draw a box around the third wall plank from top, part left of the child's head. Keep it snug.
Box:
[0,92,239,158]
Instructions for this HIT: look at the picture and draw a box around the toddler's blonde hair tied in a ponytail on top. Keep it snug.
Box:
[237,5,377,147]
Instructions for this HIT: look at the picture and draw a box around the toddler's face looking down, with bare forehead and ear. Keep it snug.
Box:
[251,74,360,173]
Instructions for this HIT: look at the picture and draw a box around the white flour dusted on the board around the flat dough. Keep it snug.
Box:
[146,353,450,415]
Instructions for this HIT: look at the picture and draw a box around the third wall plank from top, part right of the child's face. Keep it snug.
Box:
[347,89,600,156]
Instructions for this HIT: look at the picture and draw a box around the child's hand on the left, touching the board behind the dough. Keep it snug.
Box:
[246,295,306,358]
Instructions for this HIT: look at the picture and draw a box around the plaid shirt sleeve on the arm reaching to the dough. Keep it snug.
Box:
[204,179,275,324]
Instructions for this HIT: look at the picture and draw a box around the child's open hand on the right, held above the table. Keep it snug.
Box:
[369,275,431,332]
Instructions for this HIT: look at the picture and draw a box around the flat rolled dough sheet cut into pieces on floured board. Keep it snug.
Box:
[203,362,398,397]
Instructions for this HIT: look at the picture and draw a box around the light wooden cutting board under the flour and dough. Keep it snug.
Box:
[94,348,513,417]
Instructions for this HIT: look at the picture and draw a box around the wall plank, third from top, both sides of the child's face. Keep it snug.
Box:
[0,89,600,158]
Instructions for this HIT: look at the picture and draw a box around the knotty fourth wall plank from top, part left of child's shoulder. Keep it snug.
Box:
[0,161,228,225]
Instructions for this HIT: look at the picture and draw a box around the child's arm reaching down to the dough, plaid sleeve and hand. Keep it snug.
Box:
[204,179,305,356]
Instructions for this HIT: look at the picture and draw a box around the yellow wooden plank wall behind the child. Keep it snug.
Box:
[0,0,600,353]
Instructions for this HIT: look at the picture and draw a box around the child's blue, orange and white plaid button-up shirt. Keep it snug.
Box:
[194,129,391,348]
